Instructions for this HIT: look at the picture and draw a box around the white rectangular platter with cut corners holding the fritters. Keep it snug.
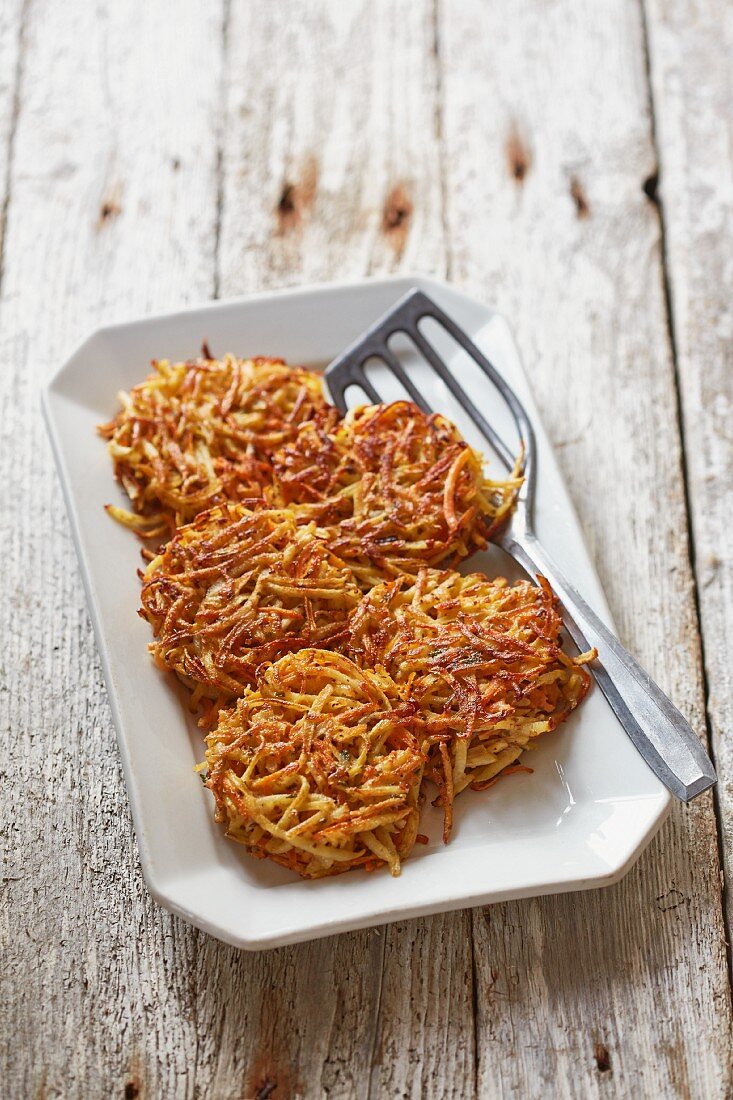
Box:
[44,276,670,949]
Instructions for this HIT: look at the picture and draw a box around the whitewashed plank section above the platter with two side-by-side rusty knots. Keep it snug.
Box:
[220,0,445,294]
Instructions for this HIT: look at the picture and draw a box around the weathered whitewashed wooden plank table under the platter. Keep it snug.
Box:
[0,0,733,1100]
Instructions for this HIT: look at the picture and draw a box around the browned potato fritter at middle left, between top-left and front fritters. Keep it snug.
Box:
[140,504,360,724]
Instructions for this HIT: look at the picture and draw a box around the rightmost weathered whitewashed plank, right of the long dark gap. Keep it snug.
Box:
[646,0,733,939]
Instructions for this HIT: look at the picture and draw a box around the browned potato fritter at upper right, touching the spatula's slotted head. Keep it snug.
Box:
[266,402,521,590]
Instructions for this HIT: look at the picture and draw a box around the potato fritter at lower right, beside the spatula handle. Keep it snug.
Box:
[348,569,595,840]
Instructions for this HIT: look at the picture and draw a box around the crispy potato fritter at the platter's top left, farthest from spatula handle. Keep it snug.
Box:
[99,355,338,539]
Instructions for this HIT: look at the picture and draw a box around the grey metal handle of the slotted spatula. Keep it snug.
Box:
[497,531,716,802]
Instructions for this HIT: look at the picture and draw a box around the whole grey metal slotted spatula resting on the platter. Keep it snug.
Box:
[326,290,716,802]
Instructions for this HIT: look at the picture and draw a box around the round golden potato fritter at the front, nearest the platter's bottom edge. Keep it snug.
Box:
[206,650,424,878]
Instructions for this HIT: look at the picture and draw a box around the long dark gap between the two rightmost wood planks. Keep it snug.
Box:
[639,0,733,1000]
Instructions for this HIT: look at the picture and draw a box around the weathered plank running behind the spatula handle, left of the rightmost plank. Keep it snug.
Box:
[439,0,732,1097]
